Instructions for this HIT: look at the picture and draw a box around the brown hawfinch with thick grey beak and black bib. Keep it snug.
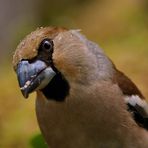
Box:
[12,26,148,148]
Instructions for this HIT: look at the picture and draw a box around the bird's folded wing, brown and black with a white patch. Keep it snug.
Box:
[116,70,148,130]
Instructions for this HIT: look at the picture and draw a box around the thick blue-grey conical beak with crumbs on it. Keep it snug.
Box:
[16,60,56,98]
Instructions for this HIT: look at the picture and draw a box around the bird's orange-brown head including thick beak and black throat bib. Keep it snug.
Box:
[13,27,113,100]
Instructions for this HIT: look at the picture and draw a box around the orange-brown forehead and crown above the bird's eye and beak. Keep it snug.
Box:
[13,27,66,69]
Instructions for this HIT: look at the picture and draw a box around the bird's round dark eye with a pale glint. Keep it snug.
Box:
[40,39,53,51]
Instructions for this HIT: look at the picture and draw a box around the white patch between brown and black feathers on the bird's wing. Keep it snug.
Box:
[124,95,148,118]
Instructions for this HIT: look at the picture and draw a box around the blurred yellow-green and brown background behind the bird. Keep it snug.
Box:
[0,0,148,148]
